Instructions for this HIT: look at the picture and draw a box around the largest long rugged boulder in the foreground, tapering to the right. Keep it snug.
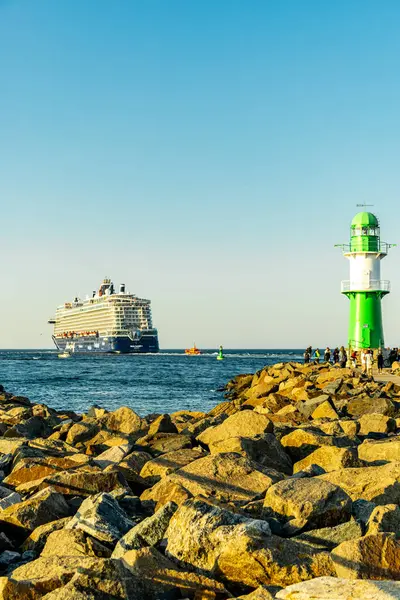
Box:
[167,499,334,587]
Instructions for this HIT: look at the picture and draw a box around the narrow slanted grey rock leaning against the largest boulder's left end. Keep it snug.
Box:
[112,502,178,558]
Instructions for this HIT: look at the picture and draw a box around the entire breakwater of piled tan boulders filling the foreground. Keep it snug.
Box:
[0,363,400,600]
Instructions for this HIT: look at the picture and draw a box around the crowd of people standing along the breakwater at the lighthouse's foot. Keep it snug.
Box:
[304,346,399,377]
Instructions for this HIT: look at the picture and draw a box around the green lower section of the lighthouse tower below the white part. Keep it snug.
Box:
[345,291,387,350]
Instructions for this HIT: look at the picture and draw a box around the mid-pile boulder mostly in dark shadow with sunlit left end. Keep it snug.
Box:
[209,433,292,475]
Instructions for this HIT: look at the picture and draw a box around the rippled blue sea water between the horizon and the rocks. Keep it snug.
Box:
[0,350,302,416]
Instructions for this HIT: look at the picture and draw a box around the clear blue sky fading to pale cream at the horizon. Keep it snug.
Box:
[0,0,400,348]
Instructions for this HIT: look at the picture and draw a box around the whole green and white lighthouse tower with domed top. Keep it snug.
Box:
[340,212,394,350]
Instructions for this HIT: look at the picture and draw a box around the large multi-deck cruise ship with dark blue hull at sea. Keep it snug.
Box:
[49,278,159,353]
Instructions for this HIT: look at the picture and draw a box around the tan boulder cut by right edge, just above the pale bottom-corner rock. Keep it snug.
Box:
[332,533,400,580]
